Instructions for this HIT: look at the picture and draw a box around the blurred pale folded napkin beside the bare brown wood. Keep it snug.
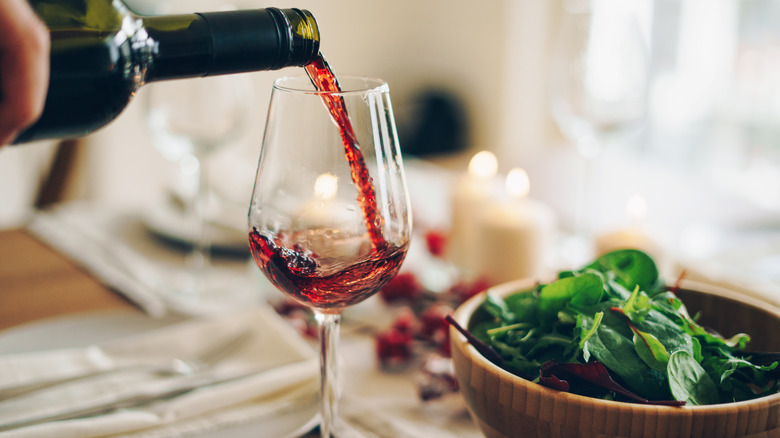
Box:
[27,201,259,317]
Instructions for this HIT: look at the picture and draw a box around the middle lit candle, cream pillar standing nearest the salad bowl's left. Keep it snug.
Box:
[474,169,557,284]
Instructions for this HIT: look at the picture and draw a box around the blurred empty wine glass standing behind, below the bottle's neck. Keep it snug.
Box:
[145,75,252,311]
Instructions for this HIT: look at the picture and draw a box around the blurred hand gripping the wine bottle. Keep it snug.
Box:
[0,0,49,147]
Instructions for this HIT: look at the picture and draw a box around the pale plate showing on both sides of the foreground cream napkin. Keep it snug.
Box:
[0,310,319,438]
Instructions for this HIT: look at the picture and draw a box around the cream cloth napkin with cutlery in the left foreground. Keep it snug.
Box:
[0,307,319,438]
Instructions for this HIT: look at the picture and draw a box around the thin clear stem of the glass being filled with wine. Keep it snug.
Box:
[315,312,341,438]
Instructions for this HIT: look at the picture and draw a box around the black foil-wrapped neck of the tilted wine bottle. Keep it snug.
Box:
[141,8,319,82]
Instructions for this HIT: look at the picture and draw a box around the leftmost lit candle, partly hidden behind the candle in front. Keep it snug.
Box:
[447,151,498,271]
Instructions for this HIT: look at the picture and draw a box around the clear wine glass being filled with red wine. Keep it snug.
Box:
[248,76,412,438]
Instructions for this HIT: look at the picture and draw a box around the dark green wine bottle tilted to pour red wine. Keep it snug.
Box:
[14,0,319,143]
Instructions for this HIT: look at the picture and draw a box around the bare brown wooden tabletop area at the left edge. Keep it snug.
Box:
[0,229,132,330]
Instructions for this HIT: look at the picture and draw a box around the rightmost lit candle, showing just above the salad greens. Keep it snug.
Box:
[594,195,658,256]
